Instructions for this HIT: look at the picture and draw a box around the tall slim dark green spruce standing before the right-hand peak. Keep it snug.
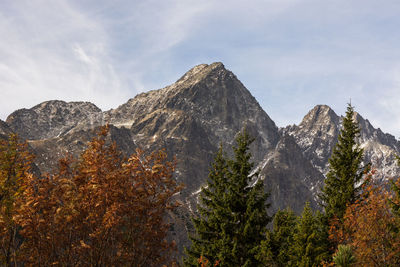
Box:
[319,104,364,221]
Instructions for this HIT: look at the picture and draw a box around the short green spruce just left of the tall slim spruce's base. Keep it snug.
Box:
[290,202,327,267]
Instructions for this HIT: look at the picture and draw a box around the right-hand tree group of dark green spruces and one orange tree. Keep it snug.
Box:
[184,105,400,267]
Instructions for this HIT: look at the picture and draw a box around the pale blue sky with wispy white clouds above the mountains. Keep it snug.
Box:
[0,0,400,138]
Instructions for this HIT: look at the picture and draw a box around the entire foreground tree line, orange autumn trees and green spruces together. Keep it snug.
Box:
[0,105,400,267]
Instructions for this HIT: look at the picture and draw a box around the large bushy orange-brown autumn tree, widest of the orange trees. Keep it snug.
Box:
[14,127,181,266]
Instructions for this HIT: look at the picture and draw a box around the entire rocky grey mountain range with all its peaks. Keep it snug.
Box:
[0,63,400,256]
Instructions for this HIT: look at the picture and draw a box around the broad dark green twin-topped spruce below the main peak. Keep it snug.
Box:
[184,132,271,266]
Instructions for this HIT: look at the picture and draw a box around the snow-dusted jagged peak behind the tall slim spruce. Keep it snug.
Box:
[280,105,400,183]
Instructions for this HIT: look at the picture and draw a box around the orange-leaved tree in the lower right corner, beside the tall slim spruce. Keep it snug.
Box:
[330,173,400,266]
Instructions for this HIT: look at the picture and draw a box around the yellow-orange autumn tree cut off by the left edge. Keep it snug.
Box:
[0,134,33,266]
